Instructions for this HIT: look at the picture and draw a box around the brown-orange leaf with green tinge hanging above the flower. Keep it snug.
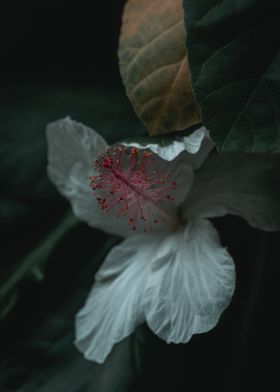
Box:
[119,0,200,135]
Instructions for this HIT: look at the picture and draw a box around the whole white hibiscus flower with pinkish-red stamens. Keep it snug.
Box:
[47,118,280,363]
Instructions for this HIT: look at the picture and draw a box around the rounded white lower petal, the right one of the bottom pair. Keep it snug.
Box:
[144,220,235,343]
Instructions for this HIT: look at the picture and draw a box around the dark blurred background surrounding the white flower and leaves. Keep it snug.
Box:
[0,0,280,392]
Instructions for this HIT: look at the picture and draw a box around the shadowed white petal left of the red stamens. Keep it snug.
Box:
[47,117,137,236]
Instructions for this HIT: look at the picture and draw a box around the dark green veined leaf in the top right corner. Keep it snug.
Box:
[183,0,280,152]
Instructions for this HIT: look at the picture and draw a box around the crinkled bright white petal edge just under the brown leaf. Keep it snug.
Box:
[124,127,214,169]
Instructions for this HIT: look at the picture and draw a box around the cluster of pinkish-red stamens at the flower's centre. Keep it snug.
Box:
[89,147,176,231]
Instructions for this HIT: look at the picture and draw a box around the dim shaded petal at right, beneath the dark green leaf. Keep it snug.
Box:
[184,153,280,231]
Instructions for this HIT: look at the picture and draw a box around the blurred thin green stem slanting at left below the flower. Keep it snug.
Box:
[0,213,78,318]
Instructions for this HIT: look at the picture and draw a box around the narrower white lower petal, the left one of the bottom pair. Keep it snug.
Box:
[75,234,161,363]
